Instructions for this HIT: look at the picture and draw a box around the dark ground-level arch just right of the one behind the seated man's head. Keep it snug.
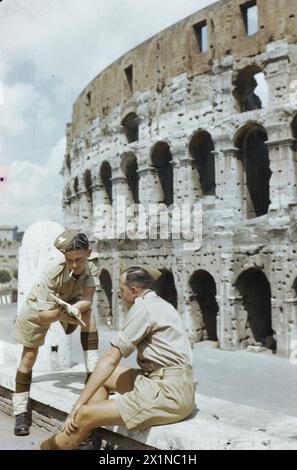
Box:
[189,270,219,341]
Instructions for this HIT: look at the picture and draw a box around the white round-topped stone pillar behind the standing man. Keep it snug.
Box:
[18,222,71,372]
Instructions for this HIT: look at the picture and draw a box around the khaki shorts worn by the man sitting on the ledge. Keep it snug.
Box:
[115,366,196,431]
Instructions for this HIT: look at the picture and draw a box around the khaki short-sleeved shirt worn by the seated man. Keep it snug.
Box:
[111,292,192,372]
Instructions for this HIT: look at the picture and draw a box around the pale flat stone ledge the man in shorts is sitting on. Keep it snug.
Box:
[0,343,297,450]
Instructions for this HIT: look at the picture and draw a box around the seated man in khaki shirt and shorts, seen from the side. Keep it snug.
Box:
[40,267,195,450]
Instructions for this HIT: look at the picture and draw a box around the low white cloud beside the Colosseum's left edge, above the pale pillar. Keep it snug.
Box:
[0,137,66,228]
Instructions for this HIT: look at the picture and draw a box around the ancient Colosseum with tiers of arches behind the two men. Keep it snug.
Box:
[62,0,297,356]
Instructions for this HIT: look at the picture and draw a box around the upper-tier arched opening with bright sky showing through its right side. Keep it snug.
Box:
[233,65,269,113]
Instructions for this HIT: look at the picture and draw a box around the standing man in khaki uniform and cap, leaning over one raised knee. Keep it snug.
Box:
[13,230,98,436]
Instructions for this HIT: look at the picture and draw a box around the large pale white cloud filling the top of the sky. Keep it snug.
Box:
[0,0,214,97]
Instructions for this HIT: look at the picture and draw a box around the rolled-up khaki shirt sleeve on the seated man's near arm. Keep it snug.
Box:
[110,304,151,357]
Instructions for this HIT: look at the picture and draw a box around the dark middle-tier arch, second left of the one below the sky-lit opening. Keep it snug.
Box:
[151,142,173,206]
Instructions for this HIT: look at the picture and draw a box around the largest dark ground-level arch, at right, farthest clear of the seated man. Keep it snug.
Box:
[235,268,276,351]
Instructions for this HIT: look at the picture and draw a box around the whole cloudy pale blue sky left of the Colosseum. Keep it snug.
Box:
[0,0,215,230]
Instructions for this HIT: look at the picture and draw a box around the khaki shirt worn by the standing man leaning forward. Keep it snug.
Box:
[20,257,99,315]
